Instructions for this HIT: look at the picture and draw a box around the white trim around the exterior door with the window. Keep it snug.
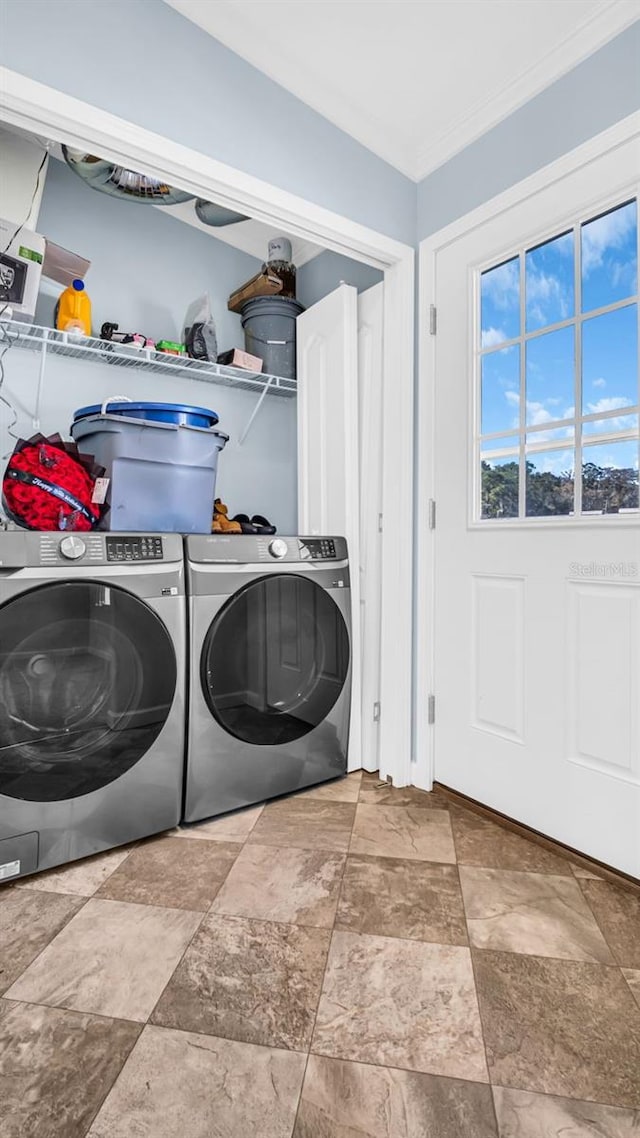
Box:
[412,112,640,790]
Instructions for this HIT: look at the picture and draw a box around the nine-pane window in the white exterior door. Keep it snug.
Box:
[474,199,640,521]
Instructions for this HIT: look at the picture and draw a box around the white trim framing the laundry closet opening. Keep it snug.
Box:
[0,67,416,786]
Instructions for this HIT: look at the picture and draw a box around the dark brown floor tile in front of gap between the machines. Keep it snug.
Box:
[98,838,243,912]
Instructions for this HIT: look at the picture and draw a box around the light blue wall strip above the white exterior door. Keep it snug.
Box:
[417,20,640,241]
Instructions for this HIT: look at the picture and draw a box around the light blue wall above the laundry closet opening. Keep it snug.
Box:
[0,0,416,244]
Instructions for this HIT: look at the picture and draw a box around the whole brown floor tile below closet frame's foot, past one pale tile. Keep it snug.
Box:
[336,855,467,945]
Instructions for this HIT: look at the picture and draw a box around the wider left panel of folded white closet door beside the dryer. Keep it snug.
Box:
[296,285,362,769]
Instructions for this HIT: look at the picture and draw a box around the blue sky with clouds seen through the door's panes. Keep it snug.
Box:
[481,201,638,480]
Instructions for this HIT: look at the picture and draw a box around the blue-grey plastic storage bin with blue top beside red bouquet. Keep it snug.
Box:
[71,402,229,534]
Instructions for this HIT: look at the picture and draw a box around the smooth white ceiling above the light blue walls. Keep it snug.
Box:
[166,0,640,181]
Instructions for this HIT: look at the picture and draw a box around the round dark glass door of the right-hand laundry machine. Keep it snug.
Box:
[200,574,350,747]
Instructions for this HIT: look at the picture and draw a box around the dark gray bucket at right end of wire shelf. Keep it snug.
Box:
[241,296,304,379]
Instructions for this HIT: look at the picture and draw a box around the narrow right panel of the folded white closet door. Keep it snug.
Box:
[358,282,385,770]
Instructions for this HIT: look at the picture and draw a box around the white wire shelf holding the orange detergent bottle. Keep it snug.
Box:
[0,320,296,397]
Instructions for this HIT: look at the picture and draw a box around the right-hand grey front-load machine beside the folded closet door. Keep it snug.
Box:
[184,535,352,822]
